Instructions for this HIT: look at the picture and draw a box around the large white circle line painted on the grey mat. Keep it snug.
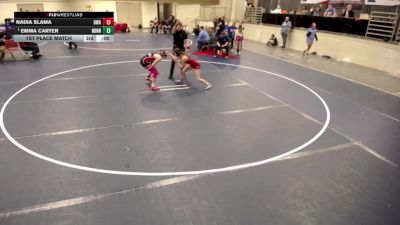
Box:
[0,60,331,176]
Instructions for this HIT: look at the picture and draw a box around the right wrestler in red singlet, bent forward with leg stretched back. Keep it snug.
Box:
[170,48,212,90]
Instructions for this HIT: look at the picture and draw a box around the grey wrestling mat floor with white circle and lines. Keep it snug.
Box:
[0,33,400,225]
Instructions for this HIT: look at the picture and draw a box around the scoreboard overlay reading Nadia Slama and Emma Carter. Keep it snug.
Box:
[14,12,114,42]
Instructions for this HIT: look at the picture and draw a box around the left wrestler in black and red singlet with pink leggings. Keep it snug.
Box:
[140,50,168,91]
